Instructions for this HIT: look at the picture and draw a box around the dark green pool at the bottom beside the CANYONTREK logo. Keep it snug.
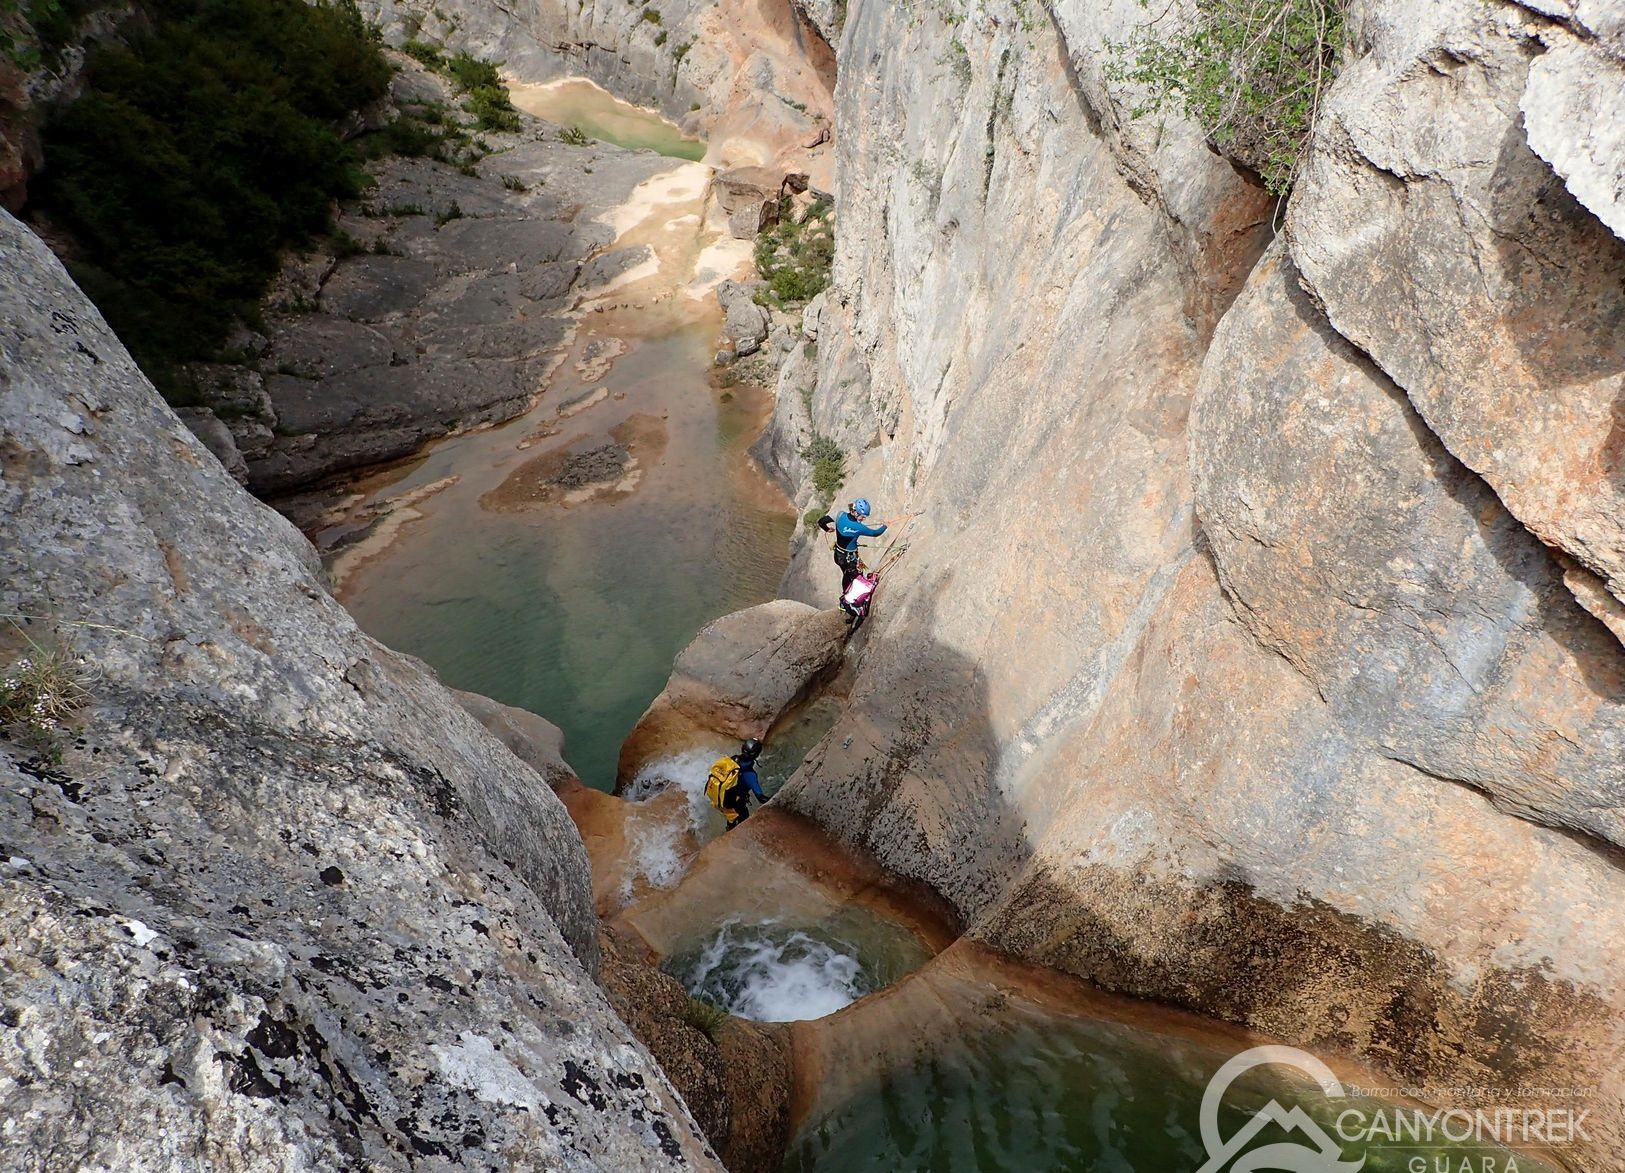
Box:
[783,991,1552,1173]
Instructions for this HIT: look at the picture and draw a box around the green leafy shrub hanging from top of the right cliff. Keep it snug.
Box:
[1108,0,1346,195]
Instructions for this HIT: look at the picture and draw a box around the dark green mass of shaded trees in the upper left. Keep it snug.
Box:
[39,0,390,400]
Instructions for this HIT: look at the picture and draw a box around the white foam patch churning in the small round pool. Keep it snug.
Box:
[678,921,871,1022]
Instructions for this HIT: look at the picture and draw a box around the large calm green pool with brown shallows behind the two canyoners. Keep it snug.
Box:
[319,315,793,790]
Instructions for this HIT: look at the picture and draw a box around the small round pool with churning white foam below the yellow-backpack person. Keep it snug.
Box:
[665,905,930,1022]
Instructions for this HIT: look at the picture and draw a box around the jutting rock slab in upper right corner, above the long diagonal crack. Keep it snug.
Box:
[1287,3,1625,610]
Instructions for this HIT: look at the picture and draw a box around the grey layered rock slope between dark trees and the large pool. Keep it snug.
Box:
[234,141,668,494]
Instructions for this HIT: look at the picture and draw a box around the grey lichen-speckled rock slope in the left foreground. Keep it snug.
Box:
[0,213,717,1171]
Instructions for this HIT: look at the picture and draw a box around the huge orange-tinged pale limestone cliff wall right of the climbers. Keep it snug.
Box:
[765,0,1625,1168]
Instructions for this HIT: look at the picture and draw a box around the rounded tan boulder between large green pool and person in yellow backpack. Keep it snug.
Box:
[616,599,848,791]
